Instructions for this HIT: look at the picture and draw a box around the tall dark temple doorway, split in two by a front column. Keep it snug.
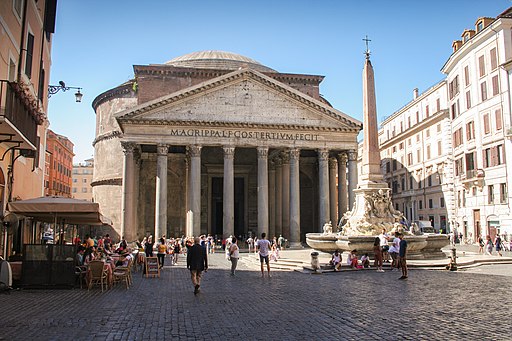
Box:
[211,177,245,237]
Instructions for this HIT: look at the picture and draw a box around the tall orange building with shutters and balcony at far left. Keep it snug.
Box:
[0,0,57,254]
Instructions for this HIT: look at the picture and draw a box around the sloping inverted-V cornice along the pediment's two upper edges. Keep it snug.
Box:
[117,69,362,130]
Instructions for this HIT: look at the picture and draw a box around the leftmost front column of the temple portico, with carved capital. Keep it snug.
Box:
[119,142,136,242]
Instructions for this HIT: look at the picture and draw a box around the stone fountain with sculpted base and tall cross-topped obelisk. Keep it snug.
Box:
[306,43,449,259]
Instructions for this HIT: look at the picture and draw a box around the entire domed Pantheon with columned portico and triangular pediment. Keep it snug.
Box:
[92,51,362,245]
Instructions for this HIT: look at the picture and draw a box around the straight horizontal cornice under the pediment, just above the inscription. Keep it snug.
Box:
[119,118,360,132]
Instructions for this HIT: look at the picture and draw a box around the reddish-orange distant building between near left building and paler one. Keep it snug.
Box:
[44,129,75,198]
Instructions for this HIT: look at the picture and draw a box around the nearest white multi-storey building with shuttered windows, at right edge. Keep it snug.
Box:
[442,9,512,240]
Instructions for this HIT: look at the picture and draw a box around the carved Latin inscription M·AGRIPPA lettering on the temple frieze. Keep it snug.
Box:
[170,129,318,141]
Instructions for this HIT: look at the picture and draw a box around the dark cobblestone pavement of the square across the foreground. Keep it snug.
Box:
[0,254,512,340]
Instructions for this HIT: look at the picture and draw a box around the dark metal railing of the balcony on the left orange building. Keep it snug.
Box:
[0,80,38,146]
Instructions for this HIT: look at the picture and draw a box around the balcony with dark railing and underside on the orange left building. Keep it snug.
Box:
[0,80,41,150]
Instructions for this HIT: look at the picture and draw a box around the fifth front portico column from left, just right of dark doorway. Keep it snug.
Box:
[257,147,273,239]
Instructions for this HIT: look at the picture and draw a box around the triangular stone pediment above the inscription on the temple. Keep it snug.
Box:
[116,69,361,131]
